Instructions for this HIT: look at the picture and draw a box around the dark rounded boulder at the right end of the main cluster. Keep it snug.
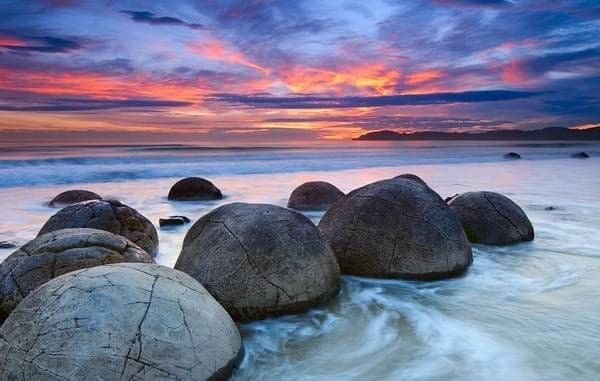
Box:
[448,192,534,245]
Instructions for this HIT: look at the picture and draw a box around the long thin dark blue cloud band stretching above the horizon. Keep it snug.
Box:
[213,90,541,109]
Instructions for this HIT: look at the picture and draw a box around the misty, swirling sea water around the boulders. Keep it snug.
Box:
[0,141,600,381]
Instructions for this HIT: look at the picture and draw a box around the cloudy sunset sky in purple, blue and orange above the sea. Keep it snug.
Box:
[0,0,600,145]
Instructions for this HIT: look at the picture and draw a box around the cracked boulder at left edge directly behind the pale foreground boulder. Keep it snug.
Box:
[0,229,153,321]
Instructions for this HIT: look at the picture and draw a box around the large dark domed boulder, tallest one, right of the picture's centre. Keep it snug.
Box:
[319,178,472,280]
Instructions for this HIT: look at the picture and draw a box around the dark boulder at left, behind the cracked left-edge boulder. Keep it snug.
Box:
[38,200,158,257]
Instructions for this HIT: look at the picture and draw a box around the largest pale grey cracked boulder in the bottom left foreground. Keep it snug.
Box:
[0,263,243,380]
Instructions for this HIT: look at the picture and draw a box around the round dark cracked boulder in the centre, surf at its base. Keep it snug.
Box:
[175,203,340,321]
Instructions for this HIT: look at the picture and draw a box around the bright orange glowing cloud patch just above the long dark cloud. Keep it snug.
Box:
[281,63,401,95]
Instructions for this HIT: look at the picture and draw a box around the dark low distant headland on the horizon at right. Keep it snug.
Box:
[352,126,600,141]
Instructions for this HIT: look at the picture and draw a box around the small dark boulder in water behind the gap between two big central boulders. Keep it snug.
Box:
[288,181,344,210]
